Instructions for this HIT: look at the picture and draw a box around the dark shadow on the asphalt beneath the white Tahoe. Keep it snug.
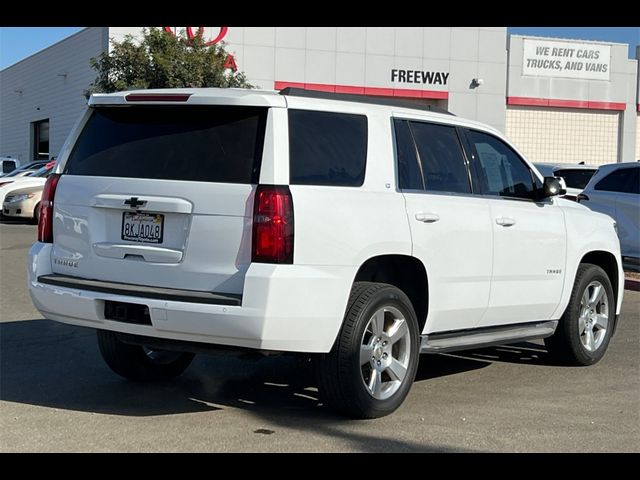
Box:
[0,320,546,426]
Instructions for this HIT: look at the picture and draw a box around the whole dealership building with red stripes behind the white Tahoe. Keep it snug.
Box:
[0,27,640,165]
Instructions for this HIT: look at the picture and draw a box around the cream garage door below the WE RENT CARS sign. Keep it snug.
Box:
[506,106,620,165]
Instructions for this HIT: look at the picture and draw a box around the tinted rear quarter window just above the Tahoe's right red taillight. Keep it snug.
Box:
[289,110,367,187]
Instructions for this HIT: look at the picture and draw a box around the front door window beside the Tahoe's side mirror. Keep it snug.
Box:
[468,130,535,198]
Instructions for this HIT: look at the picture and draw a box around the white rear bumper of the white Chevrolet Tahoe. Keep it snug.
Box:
[28,243,357,353]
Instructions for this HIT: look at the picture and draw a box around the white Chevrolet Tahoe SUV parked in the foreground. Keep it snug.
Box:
[28,89,623,418]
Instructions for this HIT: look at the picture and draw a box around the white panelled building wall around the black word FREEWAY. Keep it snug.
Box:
[224,27,507,131]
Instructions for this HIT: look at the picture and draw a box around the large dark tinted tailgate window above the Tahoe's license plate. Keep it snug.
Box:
[64,106,267,183]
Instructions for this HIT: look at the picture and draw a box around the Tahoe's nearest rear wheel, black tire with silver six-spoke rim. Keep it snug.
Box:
[317,282,420,418]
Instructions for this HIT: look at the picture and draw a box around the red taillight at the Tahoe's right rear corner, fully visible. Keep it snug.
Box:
[251,185,293,263]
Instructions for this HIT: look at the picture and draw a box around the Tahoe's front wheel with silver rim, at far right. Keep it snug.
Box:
[544,263,616,366]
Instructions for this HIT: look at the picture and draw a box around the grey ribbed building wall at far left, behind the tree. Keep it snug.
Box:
[0,27,107,163]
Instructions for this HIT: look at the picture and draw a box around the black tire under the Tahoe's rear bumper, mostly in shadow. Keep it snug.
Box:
[97,330,194,382]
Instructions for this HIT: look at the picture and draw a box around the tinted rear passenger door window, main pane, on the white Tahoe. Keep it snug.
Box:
[409,122,471,193]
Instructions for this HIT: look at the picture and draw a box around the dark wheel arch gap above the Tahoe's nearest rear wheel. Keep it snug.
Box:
[353,254,429,332]
